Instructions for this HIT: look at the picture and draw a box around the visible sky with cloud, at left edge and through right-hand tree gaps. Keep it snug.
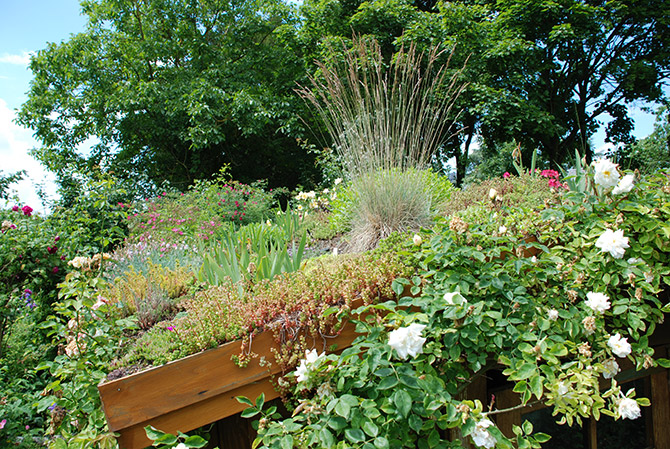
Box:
[0,0,664,214]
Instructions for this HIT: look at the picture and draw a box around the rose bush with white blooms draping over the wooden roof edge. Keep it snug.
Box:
[245,167,670,449]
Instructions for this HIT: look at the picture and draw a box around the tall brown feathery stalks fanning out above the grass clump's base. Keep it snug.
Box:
[298,38,465,179]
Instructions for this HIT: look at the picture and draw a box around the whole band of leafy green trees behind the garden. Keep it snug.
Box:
[18,0,670,188]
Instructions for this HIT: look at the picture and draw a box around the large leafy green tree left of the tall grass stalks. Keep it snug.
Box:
[19,0,314,192]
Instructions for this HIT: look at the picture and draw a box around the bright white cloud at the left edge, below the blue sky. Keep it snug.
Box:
[0,98,56,212]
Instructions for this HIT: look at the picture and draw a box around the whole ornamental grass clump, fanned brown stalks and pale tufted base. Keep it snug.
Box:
[298,38,464,251]
